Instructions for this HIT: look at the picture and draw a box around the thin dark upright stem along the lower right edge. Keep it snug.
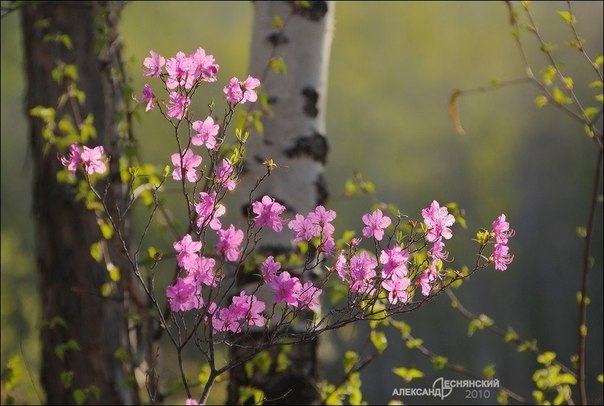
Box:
[577,150,602,405]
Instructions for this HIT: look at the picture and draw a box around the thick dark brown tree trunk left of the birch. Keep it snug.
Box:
[22,1,140,404]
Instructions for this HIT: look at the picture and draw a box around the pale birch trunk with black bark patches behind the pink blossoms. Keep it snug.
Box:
[228,1,335,404]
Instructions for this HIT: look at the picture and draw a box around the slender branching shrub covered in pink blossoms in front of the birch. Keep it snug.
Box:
[59,48,514,403]
